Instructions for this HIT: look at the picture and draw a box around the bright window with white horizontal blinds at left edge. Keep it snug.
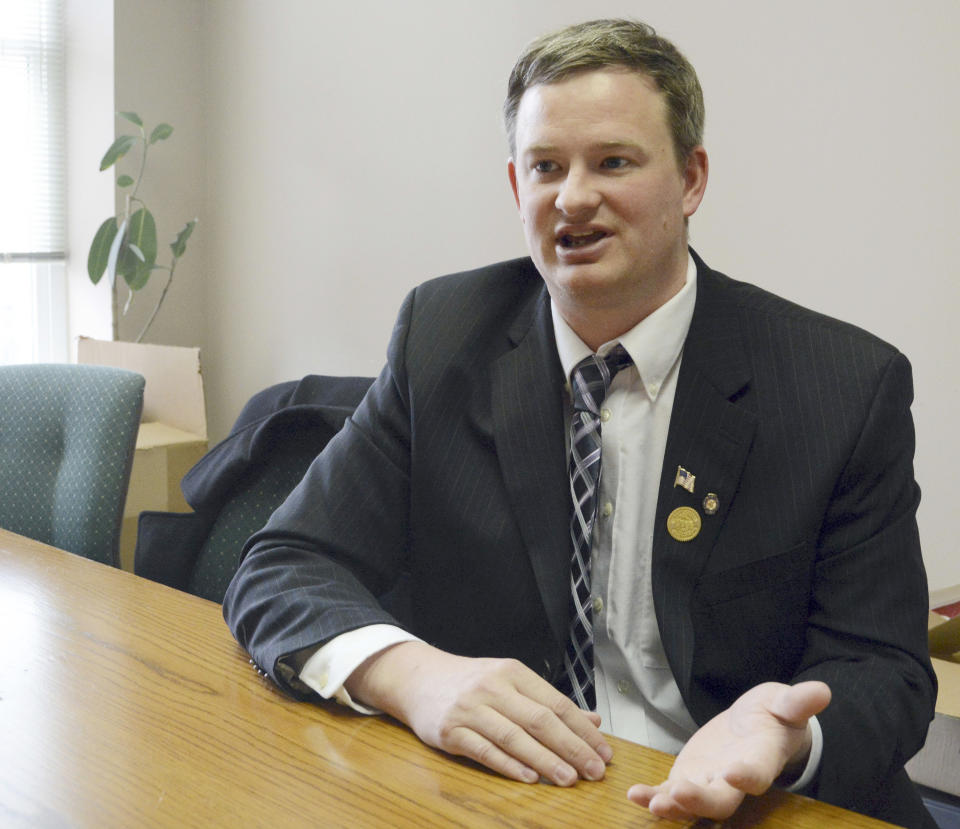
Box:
[0,0,67,363]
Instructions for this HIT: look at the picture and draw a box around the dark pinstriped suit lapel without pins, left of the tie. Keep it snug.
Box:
[491,288,570,642]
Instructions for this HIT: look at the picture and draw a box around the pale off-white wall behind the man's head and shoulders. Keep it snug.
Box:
[107,0,960,587]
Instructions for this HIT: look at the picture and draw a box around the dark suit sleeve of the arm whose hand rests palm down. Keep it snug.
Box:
[223,291,416,698]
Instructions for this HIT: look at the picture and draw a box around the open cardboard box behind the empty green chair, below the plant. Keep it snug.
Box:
[77,337,207,570]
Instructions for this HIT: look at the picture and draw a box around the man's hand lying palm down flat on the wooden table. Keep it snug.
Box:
[345,642,613,786]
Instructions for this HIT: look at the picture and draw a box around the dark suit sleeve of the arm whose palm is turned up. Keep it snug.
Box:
[796,354,936,808]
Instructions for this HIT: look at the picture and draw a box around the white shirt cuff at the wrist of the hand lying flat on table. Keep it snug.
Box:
[300,625,421,714]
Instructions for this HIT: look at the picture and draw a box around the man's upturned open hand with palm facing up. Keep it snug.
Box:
[627,682,830,820]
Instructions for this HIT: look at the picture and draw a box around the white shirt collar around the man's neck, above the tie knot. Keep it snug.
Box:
[550,254,697,399]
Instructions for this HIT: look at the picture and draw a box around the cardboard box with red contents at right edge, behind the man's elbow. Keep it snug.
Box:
[907,585,960,797]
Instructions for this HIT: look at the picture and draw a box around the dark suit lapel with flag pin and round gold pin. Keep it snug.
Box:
[652,258,756,699]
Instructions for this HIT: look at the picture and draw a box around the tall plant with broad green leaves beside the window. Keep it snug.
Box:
[87,112,197,343]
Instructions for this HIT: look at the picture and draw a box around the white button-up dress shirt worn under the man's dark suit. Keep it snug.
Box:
[300,257,823,790]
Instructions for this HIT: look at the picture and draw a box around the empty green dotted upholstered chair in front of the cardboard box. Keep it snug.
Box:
[0,364,144,566]
